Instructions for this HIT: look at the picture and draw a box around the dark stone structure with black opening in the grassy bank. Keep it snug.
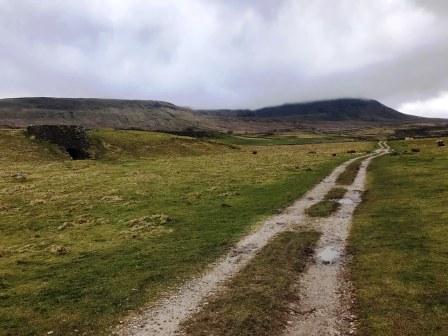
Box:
[27,125,90,160]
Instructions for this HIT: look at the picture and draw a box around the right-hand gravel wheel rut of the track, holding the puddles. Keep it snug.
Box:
[285,142,389,336]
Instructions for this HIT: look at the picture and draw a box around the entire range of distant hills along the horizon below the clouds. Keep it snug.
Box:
[0,98,431,132]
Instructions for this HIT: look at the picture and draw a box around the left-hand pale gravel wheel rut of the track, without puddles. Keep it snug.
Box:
[113,143,387,336]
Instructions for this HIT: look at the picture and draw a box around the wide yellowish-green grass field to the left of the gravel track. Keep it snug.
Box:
[0,130,373,335]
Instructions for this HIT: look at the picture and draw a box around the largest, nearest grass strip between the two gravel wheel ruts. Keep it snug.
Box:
[180,232,319,336]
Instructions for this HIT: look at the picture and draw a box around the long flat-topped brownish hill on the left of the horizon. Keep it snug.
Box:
[0,98,213,131]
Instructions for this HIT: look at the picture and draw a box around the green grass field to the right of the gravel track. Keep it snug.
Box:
[350,139,448,336]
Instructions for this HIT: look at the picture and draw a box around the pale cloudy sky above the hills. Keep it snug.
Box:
[0,0,448,117]
